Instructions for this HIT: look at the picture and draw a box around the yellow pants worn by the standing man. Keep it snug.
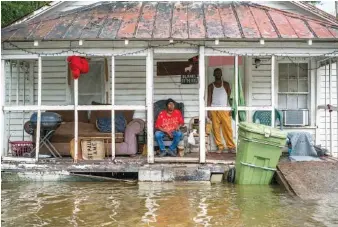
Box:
[211,111,236,150]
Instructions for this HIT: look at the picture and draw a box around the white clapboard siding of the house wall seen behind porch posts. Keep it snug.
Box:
[6,56,337,154]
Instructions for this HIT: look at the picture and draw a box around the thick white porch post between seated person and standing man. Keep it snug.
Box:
[198,46,205,163]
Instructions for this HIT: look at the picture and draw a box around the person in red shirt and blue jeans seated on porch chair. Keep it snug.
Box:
[155,99,184,157]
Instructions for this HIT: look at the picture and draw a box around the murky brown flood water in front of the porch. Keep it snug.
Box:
[1,182,338,227]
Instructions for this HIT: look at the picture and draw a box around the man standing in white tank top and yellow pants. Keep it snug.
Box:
[207,68,236,154]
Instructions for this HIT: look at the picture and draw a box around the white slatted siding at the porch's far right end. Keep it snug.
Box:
[317,63,338,157]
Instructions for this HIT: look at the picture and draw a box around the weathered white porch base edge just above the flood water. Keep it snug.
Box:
[1,154,235,182]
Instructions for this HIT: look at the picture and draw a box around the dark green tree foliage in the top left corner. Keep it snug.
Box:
[1,1,50,27]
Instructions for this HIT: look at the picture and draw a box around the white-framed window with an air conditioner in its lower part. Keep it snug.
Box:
[278,63,310,126]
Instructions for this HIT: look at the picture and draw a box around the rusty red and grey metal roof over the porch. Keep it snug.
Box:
[1,2,338,41]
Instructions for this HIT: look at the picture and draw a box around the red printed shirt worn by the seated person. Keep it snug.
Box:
[155,110,184,132]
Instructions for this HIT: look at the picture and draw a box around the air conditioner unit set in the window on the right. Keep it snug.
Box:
[284,110,309,126]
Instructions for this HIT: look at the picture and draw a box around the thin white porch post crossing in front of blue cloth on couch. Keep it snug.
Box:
[111,56,115,160]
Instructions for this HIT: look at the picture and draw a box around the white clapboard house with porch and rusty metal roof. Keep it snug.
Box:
[0,1,338,163]
